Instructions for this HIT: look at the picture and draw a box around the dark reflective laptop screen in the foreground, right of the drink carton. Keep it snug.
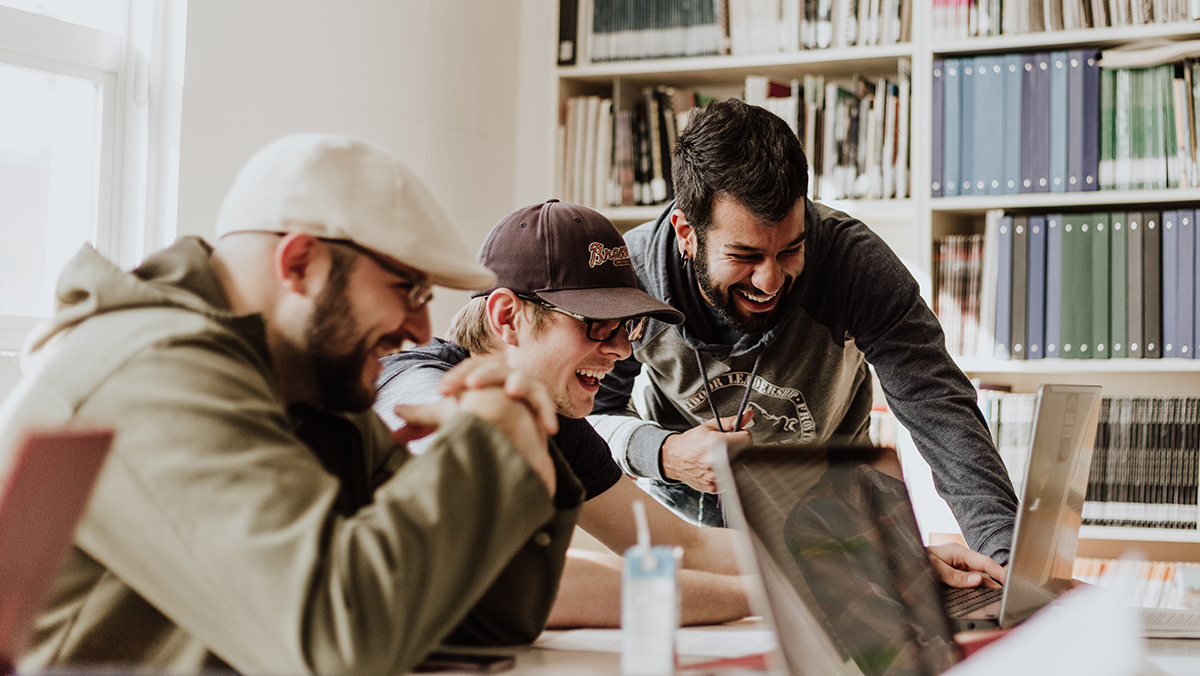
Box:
[718,445,959,676]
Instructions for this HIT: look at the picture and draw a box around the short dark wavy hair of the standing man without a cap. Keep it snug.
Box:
[671,98,809,239]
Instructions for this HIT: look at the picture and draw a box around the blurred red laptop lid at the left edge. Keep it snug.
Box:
[0,430,113,674]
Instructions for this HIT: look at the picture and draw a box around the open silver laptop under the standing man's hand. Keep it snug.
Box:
[946,385,1100,630]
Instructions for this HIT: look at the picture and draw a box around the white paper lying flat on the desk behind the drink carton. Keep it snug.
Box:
[534,629,775,657]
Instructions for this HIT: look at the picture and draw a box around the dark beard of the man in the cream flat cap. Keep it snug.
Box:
[305,258,376,413]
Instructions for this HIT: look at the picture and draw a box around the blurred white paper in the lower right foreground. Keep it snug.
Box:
[944,587,1142,676]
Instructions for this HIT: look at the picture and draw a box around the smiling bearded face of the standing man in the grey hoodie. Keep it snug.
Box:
[674,198,806,334]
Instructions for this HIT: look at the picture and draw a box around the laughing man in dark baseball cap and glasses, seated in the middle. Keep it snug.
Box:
[376,199,749,627]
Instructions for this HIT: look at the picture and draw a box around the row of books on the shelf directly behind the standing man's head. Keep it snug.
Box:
[556,65,911,209]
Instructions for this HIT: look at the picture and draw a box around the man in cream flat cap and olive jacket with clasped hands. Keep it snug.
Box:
[0,134,582,675]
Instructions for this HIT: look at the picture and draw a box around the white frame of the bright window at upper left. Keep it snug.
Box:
[0,5,186,352]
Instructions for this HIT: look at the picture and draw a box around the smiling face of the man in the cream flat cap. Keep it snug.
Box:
[305,245,432,412]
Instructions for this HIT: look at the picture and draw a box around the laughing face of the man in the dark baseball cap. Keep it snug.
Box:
[508,304,632,418]
